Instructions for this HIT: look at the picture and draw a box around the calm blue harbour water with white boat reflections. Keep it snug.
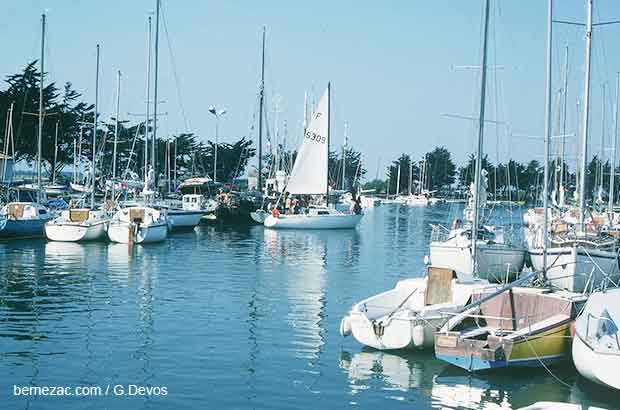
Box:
[0,206,618,409]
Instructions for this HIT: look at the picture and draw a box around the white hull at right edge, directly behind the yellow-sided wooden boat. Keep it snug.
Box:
[530,247,620,293]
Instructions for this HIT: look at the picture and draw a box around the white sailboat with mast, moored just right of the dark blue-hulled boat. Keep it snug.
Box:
[45,44,109,242]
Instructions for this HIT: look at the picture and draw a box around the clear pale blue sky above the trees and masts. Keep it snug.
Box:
[0,0,620,179]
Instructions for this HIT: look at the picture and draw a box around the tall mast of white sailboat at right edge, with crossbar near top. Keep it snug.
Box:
[579,0,592,233]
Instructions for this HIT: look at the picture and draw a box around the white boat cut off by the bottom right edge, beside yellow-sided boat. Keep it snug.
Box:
[573,288,620,390]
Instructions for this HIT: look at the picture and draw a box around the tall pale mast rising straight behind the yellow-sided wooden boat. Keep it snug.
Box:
[543,0,553,274]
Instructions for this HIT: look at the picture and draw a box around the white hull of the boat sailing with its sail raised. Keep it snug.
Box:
[265,214,363,229]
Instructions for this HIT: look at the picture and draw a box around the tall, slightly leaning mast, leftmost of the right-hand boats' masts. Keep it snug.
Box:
[471,0,489,274]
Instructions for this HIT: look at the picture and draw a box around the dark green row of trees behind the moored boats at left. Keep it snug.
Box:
[0,61,255,185]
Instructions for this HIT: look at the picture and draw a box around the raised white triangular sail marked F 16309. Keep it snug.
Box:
[286,88,329,194]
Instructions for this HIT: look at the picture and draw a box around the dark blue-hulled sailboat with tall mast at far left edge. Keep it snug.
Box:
[0,14,53,239]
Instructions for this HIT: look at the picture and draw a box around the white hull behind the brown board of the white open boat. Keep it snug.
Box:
[430,242,525,282]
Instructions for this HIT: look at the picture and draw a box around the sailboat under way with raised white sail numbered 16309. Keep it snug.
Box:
[265,84,363,229]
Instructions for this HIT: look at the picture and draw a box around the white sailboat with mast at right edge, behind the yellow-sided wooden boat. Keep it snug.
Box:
[529,0,620,292]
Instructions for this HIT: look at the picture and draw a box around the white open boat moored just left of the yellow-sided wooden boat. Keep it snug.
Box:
[341,278,489,350]
